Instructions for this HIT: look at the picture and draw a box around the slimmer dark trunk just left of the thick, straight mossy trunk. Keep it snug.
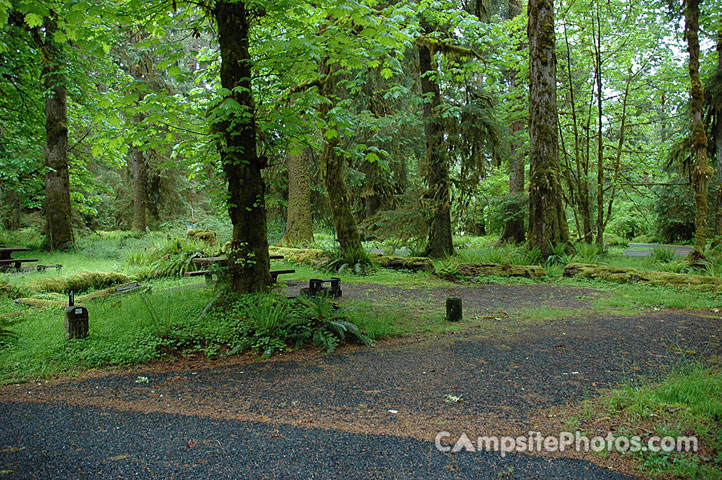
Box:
[499,0,526,243]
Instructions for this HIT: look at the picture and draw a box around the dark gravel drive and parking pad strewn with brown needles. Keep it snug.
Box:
[0,285,722,479]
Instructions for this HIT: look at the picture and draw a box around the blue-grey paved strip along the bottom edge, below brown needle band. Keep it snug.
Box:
[0,402,629,480]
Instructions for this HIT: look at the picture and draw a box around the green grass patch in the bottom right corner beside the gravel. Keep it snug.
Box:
[565,361,722,479]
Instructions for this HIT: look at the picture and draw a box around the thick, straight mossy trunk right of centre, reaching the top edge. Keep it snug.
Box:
[527,0,569,257]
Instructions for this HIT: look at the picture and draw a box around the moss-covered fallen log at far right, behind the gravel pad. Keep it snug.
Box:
[562,263,722,286]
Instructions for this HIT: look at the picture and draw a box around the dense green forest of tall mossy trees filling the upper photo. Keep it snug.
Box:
[0,0,722,291]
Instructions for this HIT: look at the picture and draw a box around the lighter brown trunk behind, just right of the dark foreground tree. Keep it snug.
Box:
[281,147,313,246]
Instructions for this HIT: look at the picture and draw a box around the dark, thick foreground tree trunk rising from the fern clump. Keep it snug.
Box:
[213,2,271,293]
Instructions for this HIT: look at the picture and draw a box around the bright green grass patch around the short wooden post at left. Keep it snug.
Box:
[0,287,211,383]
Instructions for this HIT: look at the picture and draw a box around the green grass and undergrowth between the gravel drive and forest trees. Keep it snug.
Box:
[0,232,722,382]
